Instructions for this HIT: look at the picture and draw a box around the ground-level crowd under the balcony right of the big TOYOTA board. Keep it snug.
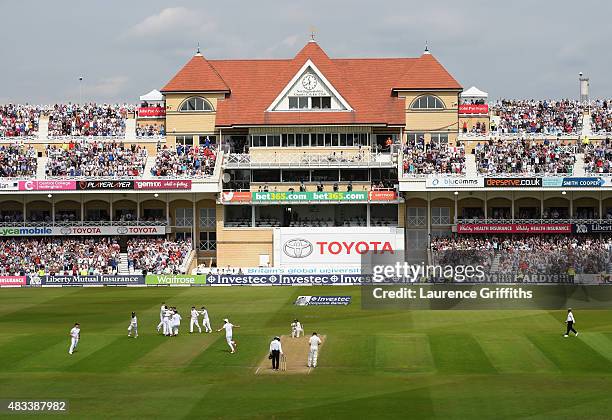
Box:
[431,235,612,278]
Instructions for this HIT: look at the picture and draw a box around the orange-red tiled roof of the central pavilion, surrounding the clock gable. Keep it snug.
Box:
[162,42,461,127]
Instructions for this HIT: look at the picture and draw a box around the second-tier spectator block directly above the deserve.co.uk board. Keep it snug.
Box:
[474,139,576,175]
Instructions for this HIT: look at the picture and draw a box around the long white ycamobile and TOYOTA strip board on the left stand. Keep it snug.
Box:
[0,226,166,236]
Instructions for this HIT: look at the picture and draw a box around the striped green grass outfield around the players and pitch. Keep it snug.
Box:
[0,287,612,419]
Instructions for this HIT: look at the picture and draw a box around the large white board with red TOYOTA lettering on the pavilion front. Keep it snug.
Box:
[274,227,404,267]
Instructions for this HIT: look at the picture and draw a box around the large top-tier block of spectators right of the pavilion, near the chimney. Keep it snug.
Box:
[489,99,585,135]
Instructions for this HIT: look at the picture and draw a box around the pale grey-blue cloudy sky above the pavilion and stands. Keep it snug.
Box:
[0,0,612,104]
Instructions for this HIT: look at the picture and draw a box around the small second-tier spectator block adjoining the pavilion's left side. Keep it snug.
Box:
[151,142,217,178]
